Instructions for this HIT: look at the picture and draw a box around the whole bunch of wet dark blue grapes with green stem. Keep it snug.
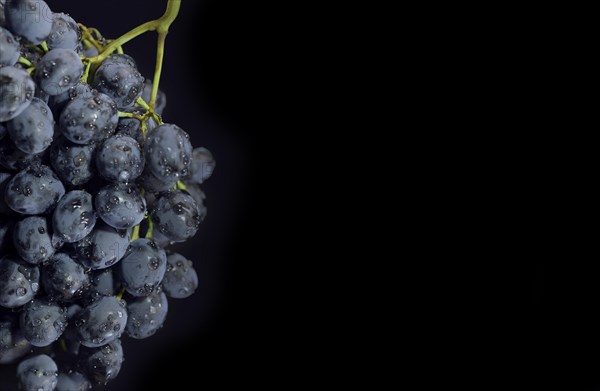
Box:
[0,0,215,391]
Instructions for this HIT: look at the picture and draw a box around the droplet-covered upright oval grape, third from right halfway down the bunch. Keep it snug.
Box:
[52,190,96,243]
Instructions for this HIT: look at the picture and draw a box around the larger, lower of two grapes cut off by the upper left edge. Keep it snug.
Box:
[0,67,35,122]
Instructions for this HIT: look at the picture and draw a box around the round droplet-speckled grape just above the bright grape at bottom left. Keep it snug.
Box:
[20,298,67,347]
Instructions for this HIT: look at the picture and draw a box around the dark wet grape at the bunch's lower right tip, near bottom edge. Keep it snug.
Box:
[79,339,123,384]
